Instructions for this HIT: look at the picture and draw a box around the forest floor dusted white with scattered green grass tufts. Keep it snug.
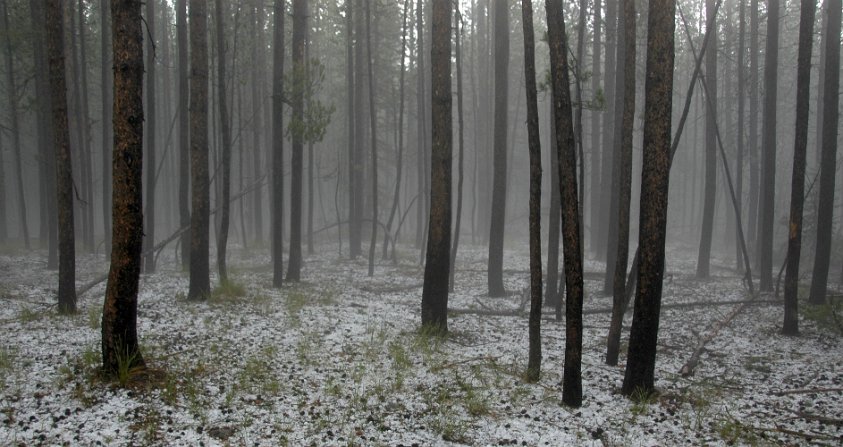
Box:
[0,246,843,446]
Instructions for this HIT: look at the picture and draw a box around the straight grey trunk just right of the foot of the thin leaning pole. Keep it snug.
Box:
[756,0,779,292]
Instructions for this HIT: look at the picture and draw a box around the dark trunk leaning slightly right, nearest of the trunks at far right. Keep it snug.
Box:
[782,0,817,335]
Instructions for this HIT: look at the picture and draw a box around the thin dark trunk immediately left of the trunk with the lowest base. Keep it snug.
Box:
[521,0,544,382]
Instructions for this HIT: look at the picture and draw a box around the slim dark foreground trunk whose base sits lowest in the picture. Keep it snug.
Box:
[545,0,583,407]
